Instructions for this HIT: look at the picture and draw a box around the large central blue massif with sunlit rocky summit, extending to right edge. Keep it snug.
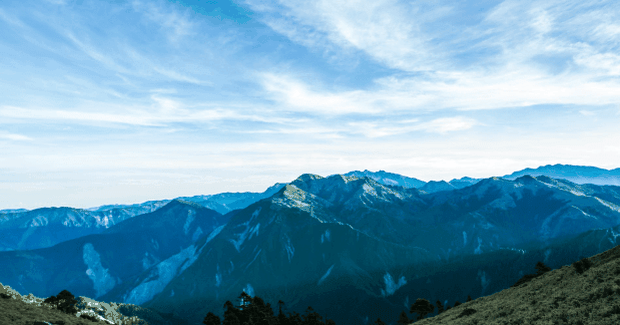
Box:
[104,174,620,324]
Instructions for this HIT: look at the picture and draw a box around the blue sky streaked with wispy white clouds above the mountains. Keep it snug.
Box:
[0,0,620,209]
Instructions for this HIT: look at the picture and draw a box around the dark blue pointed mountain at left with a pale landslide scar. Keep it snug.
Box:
[0,200,228,298]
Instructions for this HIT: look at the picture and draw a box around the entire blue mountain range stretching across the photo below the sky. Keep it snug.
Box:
[0,168,620,324]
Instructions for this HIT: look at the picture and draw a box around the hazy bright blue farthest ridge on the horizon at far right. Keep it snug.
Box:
[503,164,620,186]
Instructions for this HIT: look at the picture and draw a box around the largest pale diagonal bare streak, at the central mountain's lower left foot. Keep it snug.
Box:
[123,245,204,305]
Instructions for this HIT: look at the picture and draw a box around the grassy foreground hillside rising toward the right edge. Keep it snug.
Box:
[415,246,620,325]
